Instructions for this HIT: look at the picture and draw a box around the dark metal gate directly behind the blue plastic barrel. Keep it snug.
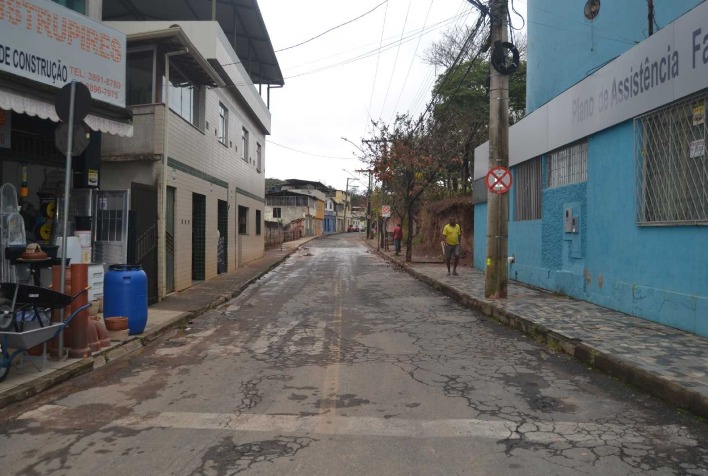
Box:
[128,182,158,304]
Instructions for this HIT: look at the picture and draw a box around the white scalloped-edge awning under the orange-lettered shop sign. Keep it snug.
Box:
[0,75,133,137]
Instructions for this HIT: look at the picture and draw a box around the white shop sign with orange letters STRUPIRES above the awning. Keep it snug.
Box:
[0,0,126,107]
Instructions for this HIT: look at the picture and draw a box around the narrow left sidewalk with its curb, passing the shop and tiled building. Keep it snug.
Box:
[0,237,314,408]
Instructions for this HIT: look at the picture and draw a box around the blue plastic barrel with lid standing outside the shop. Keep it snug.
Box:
[103,264,147,335]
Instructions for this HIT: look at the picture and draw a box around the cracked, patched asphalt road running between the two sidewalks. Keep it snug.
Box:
[0,234,708,476]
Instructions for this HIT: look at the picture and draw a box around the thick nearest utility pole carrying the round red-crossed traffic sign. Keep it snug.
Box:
[484,0,509,298]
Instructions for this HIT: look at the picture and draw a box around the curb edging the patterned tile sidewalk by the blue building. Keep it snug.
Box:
[374,243,708,418]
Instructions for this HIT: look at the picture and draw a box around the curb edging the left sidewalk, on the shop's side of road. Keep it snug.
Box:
[0,240,311,409]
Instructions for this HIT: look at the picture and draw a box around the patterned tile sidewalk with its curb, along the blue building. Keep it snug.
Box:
[367,242,708,418]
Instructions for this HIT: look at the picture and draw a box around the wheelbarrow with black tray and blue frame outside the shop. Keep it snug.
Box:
[0,283,91,382]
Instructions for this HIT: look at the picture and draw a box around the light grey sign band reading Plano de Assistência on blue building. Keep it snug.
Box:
[548,3,708,149]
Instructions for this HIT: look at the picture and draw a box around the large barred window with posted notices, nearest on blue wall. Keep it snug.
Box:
[634,93,708,225]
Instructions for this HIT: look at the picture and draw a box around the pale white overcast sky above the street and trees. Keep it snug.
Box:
[258,0,526,190]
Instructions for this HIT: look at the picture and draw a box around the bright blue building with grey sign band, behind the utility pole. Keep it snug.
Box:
[474,0,708,336]
